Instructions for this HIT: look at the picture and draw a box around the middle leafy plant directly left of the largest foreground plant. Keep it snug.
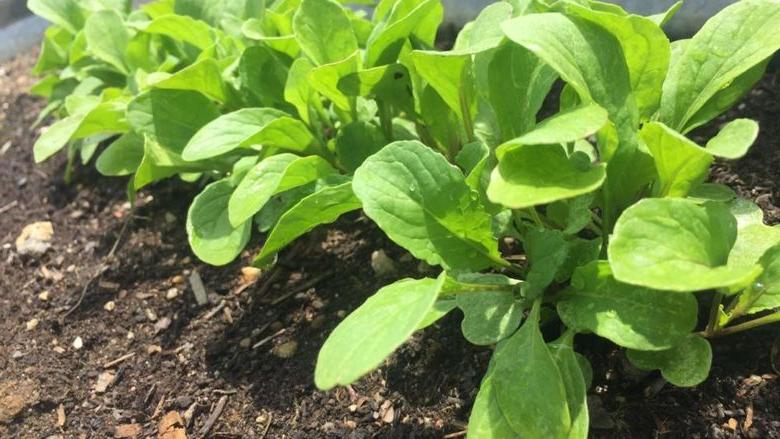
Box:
[182,0,450,265]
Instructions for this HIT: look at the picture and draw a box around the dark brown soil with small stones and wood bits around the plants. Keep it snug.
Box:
[0,49,780,438]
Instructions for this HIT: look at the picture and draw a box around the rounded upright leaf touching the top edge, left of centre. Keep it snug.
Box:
[293,0,358,65]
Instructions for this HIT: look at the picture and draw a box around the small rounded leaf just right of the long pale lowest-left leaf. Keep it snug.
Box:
[455,274,525,345]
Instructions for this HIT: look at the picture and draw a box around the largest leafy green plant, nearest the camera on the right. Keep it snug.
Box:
[315,0,780,438]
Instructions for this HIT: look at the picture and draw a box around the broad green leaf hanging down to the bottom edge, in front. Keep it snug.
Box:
[493,304,571,439]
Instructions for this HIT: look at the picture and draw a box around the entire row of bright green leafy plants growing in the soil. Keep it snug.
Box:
[29,0,780,438]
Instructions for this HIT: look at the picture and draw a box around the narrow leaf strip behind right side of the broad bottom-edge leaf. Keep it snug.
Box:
[548,332,590,439]
